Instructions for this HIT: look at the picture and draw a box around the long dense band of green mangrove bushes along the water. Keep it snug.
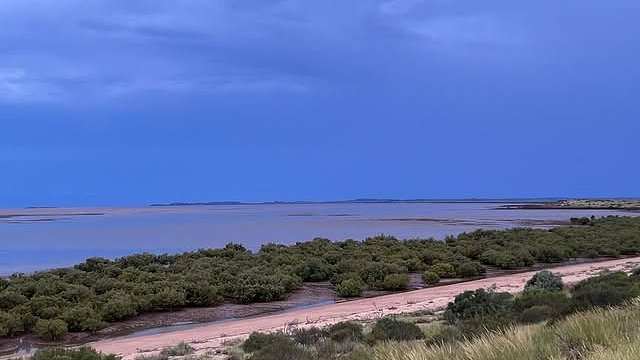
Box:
[0,217,640,340]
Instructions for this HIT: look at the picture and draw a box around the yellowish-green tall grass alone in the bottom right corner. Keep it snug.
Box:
[374,303,640,360]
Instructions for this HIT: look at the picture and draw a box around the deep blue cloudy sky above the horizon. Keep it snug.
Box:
[0,0,640,207]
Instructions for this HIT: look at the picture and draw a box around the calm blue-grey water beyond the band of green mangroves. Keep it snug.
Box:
[0,203,629,274]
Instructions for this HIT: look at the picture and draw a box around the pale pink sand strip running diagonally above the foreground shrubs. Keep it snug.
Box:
[90,257,640,360]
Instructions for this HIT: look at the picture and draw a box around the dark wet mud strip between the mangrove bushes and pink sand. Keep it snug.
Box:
[0,256,640,359]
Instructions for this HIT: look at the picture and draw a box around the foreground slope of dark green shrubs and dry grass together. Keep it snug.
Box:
[238,271,640,360]
